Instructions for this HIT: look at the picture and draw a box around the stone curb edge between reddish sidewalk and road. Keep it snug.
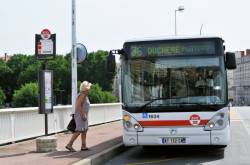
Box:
[72,143,125,165]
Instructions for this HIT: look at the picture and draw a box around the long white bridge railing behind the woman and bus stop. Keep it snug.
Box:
[0,103,122,144]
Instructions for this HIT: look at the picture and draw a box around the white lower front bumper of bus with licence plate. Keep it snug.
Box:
[123,127,230,146]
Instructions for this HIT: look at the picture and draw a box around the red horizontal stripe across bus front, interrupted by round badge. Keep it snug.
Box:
[139,120,209,127]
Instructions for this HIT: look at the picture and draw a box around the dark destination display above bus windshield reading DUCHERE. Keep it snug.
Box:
[125,41,215,58]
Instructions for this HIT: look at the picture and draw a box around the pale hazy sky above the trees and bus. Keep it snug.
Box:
[0,0,250,56]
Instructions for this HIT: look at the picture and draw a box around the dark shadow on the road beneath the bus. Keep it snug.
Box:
[105,146,224,165]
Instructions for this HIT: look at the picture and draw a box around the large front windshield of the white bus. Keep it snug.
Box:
[122,56,226,108]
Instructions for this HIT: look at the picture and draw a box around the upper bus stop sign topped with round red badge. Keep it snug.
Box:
[35,29,56,59]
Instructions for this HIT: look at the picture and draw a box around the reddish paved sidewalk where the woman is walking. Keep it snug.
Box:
[0,121,122,165]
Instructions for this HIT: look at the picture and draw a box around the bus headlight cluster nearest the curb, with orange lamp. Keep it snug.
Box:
[123,113,143,132]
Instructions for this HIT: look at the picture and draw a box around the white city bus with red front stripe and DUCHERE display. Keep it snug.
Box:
[108,36,236,148]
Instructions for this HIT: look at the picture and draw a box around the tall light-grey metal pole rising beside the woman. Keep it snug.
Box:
[71,0,77,113]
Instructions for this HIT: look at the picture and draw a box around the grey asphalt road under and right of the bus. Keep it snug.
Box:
[105,107,250,165]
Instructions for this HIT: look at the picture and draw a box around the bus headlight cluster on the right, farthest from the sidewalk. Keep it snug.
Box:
[204,110,228,131]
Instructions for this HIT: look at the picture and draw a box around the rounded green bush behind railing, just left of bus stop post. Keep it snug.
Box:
[12,83,38,107]
